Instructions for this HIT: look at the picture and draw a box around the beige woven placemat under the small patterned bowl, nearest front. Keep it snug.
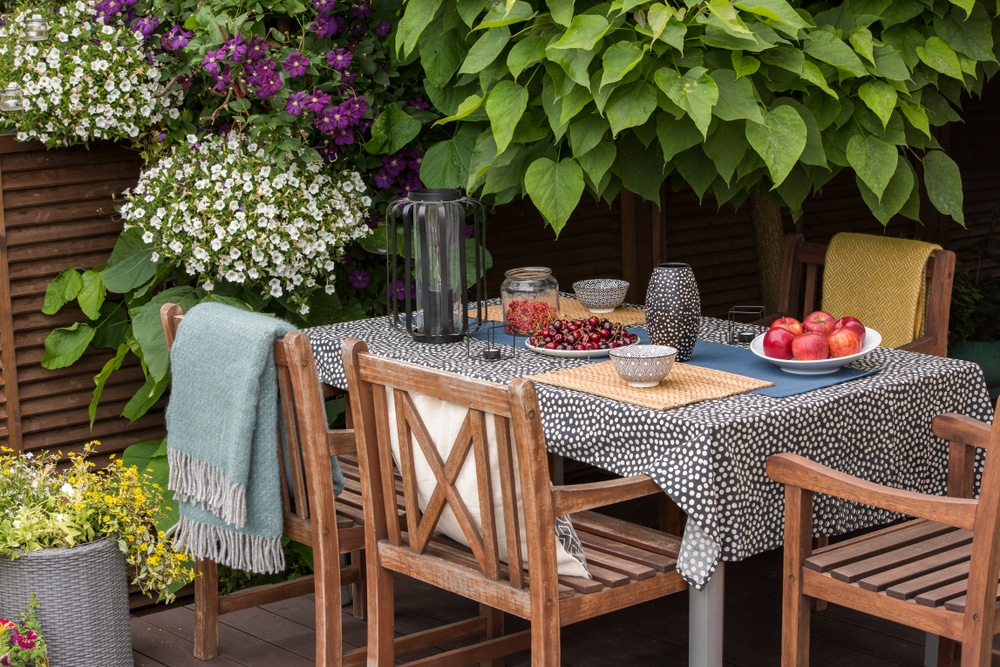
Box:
[529,361,774,410]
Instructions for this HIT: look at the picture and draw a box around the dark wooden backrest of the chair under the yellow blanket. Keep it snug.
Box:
[778,234,955,357]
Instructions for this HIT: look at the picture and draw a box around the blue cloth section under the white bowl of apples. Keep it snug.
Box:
[688,340,878,398]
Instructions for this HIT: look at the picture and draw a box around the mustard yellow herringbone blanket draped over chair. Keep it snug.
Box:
[823,233,941,347]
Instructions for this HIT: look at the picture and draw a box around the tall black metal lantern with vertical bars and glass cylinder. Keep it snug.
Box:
[387,189,486,343]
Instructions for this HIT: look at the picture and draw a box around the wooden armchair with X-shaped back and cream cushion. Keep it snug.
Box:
[334,340,687,666]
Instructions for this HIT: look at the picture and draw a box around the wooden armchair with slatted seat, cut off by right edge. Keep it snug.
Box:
[767,405,1000,667]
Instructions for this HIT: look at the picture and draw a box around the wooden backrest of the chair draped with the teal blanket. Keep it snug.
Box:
[160,303,354,546]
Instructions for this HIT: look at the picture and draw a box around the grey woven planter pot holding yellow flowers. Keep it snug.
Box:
[0,540,134,667]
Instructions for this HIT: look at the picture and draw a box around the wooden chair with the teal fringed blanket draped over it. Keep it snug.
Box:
[160,304,366,666]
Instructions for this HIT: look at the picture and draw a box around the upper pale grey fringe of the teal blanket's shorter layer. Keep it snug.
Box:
[167,448,247,528]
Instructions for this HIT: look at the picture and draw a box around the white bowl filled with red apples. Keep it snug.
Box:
[750,310,882,375]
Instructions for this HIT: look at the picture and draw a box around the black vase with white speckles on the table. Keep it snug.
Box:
[646,262,701,361]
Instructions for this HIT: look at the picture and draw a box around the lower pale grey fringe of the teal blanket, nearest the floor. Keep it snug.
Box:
[174,516,285,574]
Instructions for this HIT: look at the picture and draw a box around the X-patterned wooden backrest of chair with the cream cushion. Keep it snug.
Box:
[344,340,556,589]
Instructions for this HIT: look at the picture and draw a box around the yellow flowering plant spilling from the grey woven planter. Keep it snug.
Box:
[0,441,191,602]
